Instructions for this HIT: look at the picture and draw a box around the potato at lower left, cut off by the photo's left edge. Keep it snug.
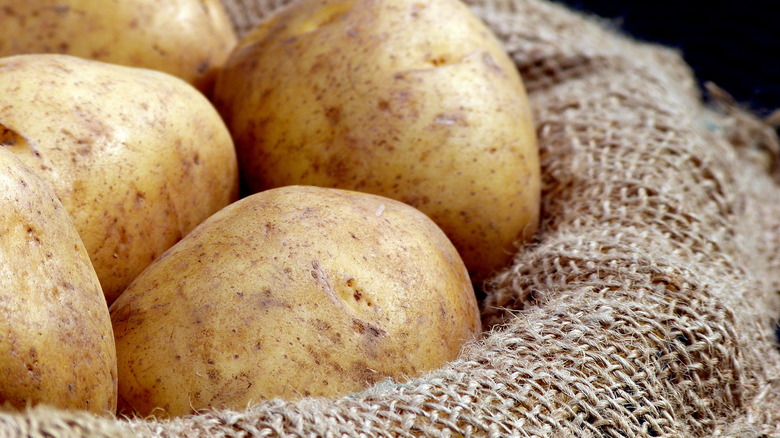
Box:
[0,146,117,414]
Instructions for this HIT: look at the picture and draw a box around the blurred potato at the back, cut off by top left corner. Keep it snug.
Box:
[0,0,237,94]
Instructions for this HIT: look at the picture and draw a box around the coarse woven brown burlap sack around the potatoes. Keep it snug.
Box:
[0,0,780,437]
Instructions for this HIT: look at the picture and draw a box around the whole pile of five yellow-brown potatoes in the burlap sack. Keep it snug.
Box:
[0,0,540,417]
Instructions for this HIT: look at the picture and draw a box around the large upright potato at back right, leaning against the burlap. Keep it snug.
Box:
[214,0,540,281]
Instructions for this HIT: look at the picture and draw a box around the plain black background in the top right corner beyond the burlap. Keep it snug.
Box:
[556,0,780,116]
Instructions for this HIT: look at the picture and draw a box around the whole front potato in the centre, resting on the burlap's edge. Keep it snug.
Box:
[110,186,481,416]
